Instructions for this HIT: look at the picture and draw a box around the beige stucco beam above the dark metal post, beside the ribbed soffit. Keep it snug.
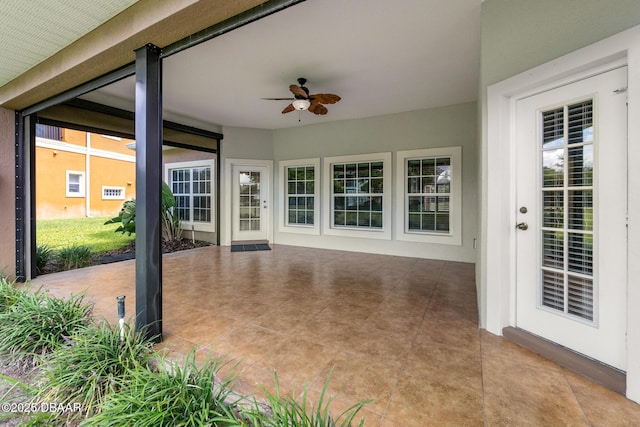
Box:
[0,0,272,110]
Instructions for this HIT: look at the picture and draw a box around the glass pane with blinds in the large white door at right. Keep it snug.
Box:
[540,99,595,321]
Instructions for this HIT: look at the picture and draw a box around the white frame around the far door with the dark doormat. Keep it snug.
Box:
[220,159,275,246]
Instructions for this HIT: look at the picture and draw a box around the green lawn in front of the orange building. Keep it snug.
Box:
[36,217,135,252]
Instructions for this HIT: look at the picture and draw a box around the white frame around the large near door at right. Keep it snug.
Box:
[479,26,640,402]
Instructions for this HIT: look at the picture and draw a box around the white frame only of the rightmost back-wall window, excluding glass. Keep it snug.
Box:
[395,146,462,246]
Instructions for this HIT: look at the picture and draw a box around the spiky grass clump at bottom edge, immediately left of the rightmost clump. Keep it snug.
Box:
[83,350,246,427]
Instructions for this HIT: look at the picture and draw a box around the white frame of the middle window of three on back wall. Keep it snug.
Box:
[322,152,393,240]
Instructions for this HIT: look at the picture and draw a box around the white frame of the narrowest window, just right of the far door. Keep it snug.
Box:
[278,158,322,236]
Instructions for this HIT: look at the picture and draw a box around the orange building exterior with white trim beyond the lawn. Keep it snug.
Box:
[35,125,136,219]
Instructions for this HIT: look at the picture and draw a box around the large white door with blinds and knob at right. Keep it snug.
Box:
[515,67,627,370]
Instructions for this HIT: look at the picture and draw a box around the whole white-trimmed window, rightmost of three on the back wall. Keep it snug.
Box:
[396,147,462,245]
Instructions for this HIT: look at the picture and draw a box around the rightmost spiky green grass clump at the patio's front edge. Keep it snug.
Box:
[245,372,369,427]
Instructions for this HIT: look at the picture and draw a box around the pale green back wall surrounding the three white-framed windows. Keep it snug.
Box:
[274,103,477,262]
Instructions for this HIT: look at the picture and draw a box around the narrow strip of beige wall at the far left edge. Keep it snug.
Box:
[0,108,16,278]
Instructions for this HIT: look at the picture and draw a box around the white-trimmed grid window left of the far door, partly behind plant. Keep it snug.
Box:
[165,160,215,232]
